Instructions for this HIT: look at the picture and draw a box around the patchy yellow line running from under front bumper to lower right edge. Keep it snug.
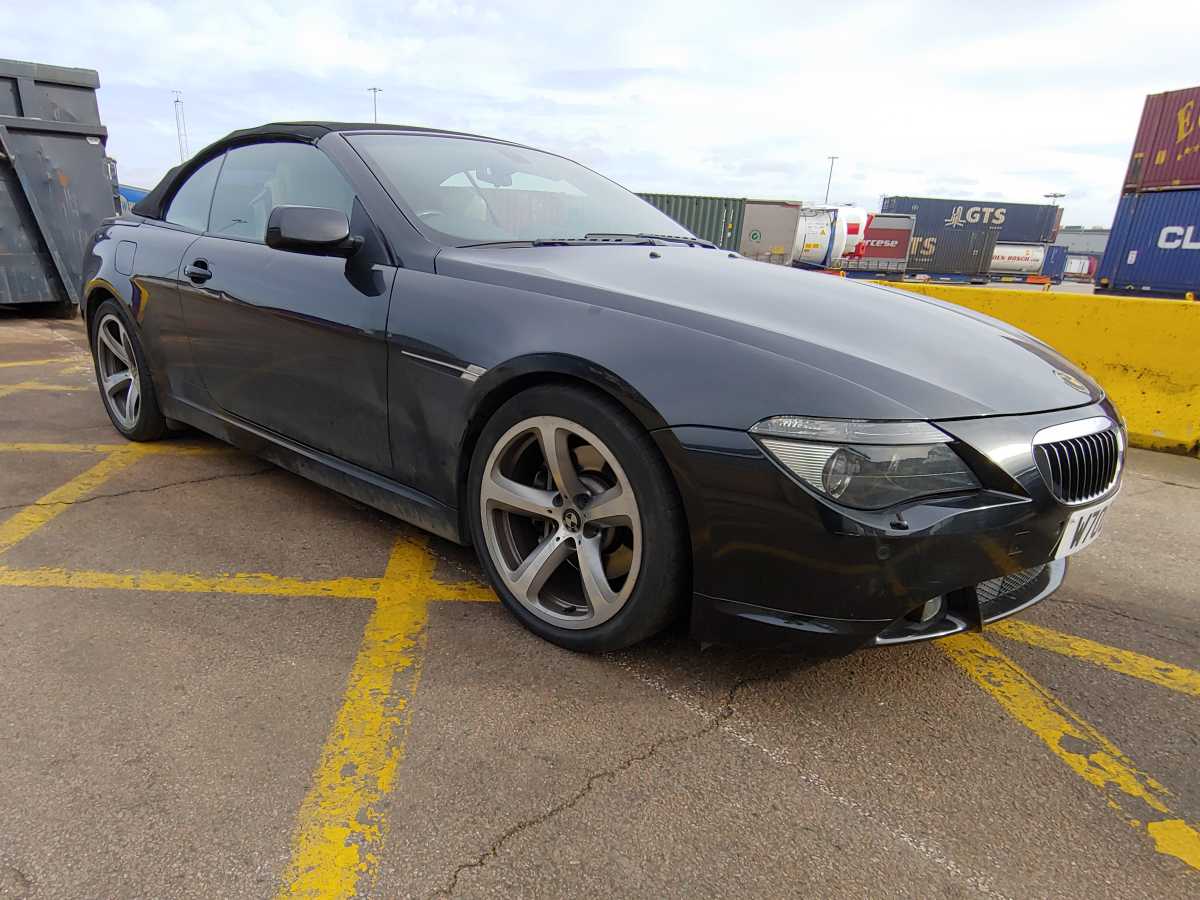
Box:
[938,634,1200,870]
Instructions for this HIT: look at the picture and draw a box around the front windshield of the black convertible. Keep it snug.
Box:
[347,133,691,246]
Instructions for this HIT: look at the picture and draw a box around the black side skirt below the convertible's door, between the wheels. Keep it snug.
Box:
[163,397,470,546]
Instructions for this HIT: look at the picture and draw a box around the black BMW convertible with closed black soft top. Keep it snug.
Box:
[82,122,1127,654]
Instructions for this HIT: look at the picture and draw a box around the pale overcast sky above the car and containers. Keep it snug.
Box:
[0,0,1200,226]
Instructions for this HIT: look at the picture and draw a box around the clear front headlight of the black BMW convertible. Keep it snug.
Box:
[750,415,979,509]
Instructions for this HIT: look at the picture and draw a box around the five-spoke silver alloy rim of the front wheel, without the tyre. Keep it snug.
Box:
[479,415,642,629]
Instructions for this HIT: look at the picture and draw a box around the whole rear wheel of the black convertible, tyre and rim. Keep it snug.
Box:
[91,300,167,440]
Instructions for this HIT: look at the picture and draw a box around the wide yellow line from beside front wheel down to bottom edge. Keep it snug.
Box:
[278,538,439,898]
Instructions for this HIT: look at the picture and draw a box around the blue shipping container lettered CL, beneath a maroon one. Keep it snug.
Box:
[1096,190,1200,296]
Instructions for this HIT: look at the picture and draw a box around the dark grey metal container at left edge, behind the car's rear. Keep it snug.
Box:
[0,60,118,312]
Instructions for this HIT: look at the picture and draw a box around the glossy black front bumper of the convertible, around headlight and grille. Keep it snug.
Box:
[655,401,1120,653]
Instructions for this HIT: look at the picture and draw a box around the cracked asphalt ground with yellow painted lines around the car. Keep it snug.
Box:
[0,313,1200,899]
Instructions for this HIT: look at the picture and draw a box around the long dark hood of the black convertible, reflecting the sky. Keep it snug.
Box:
[437,245,1103,419]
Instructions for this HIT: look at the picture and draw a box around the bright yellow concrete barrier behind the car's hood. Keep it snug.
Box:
[878,282,1200,456]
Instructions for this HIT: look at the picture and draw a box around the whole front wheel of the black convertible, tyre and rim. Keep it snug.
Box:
[468,385,689,652]
